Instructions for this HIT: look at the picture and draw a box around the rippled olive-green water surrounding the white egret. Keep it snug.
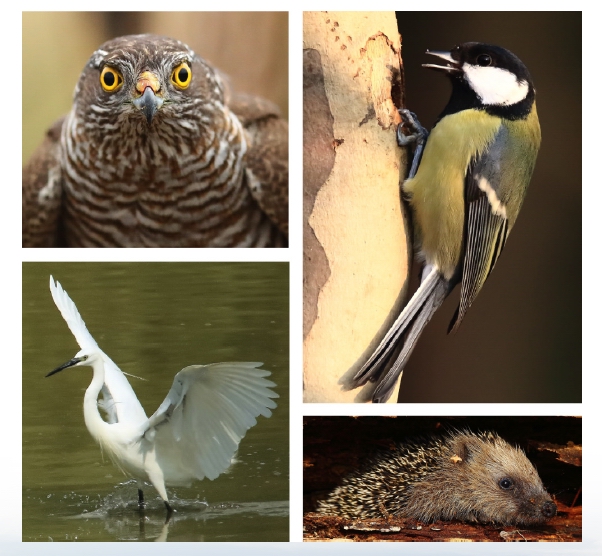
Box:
[23,263,289,541]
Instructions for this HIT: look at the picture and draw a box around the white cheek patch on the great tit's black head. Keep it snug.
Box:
[462,64,529,106]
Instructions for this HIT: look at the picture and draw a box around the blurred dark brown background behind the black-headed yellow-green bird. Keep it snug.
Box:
[398,12,580,402]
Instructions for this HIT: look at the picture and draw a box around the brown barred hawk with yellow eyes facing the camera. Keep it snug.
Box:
[23,35,288,247]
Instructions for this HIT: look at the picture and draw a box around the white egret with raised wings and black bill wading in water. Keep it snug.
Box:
[46,276,278,516]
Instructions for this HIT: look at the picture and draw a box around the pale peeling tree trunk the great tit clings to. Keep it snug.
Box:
[303,12,411,402]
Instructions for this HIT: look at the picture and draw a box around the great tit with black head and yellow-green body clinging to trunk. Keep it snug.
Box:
[354,42,541,403]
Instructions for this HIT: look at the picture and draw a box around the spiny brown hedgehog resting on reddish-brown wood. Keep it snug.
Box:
[317,430,556,526]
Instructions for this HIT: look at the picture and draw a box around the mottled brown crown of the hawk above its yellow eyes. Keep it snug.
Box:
[89,35,195,68]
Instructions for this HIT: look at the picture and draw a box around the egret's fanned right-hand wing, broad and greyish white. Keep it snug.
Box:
[144,363,278,485]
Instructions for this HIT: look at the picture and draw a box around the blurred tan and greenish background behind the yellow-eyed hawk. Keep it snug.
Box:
[23,12,288,163]
